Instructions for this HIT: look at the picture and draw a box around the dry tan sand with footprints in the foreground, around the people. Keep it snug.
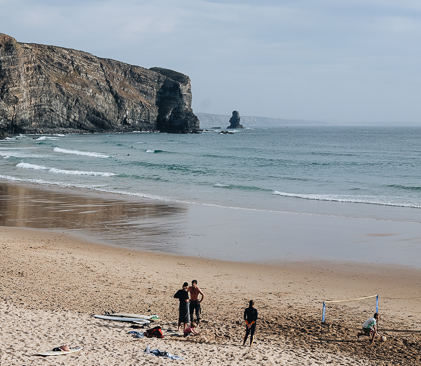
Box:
[0,227,421,366]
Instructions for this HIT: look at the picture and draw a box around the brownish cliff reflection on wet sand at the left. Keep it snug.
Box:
[0,183,187,252]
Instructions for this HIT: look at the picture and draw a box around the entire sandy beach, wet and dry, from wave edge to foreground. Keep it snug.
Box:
[0,183,421,366]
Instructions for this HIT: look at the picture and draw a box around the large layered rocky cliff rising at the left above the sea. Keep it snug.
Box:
[0,33,199,135]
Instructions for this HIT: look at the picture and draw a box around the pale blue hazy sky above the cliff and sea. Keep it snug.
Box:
[0,0,421,125]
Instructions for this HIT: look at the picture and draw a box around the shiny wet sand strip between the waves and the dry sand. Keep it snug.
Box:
[0,183,421,269]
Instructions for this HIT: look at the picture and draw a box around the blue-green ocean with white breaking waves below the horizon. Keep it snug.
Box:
[0,126,421,268]
